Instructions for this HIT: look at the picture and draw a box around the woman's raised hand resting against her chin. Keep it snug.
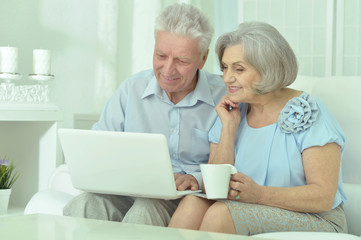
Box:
[216,95,241,128]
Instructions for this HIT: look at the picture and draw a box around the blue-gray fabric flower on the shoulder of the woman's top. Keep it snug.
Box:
[278,93,318,133]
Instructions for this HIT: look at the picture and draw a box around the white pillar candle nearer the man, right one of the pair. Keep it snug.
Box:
[33,49,51,75]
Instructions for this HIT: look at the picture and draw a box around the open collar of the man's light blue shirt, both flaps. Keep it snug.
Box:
[142,70,215,107]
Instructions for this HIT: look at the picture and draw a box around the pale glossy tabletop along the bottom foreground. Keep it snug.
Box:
[0,214,264,240]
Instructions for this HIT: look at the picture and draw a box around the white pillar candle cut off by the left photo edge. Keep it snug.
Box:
[0,47,18,73]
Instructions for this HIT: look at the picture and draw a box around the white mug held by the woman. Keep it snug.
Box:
[200,164,237,199]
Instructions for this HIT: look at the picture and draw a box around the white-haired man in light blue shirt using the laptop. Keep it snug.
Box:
[64,4,226,226]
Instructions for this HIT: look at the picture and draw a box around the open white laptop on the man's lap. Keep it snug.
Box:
[58,128,200,199]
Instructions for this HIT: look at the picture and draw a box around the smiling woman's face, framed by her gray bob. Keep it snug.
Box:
[221,44,261,103]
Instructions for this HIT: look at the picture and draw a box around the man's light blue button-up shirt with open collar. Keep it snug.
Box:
[93,70,226,188]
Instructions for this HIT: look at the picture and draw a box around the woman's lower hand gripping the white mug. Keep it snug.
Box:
[228,172,262,203]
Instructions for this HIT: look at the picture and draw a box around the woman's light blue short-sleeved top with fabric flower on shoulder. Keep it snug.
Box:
[209,92,346,208]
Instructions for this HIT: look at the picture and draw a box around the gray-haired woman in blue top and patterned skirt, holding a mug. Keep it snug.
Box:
[169,22,347,235]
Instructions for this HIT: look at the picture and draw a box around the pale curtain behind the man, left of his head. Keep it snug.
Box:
[94,0,165,113]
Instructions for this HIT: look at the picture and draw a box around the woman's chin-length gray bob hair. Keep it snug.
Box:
[216,22,298,94]
